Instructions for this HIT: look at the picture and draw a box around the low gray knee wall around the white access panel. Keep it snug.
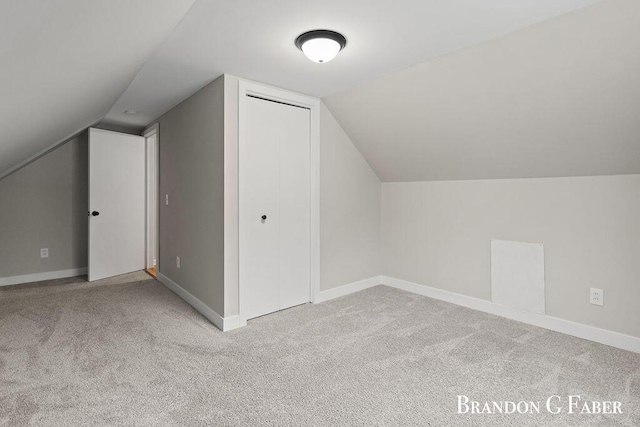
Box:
[382,175,640,337]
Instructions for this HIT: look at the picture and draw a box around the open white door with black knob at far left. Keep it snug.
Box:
[89,129,145,281]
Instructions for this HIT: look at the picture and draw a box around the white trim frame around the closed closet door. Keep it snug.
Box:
[238,79,320,325]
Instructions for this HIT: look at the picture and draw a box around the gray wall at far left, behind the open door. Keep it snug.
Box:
[0,133,88,278]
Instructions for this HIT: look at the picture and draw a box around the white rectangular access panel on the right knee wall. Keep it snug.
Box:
[491,240,545,314]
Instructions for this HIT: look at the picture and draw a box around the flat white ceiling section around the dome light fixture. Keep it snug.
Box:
[106,0,597,130]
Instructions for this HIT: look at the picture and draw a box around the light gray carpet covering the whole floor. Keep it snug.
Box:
[0,275,640,426]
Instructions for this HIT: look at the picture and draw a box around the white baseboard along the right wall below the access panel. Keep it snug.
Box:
[382,276,640,353]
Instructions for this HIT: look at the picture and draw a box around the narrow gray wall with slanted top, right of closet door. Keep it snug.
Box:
[320,103,382,290]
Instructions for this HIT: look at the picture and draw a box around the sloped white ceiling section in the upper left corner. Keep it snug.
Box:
[0,0,193,177]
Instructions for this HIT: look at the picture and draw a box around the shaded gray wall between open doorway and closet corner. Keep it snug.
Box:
[158,78,224,315]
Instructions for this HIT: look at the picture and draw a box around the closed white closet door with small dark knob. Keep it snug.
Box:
[239,97,311,319]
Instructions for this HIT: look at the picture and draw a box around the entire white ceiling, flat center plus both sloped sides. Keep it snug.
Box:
[0,0,640,181]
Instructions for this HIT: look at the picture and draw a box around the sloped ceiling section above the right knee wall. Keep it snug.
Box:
[324,0,640,181]
